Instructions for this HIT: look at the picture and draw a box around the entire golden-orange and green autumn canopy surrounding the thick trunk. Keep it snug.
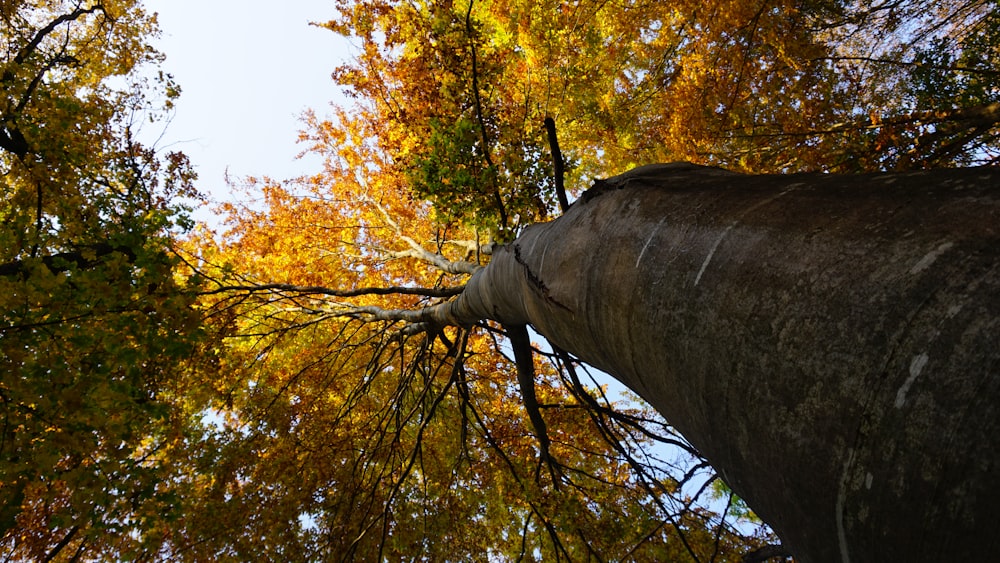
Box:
[0,0,1000,561]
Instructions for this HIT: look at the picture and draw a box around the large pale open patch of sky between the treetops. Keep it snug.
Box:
[145,0,351,220]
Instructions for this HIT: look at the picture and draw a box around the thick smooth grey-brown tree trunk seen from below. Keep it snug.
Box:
[442,165,1000,563]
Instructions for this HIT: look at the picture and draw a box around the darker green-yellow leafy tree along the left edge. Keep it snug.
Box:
[0,1,211,561]
